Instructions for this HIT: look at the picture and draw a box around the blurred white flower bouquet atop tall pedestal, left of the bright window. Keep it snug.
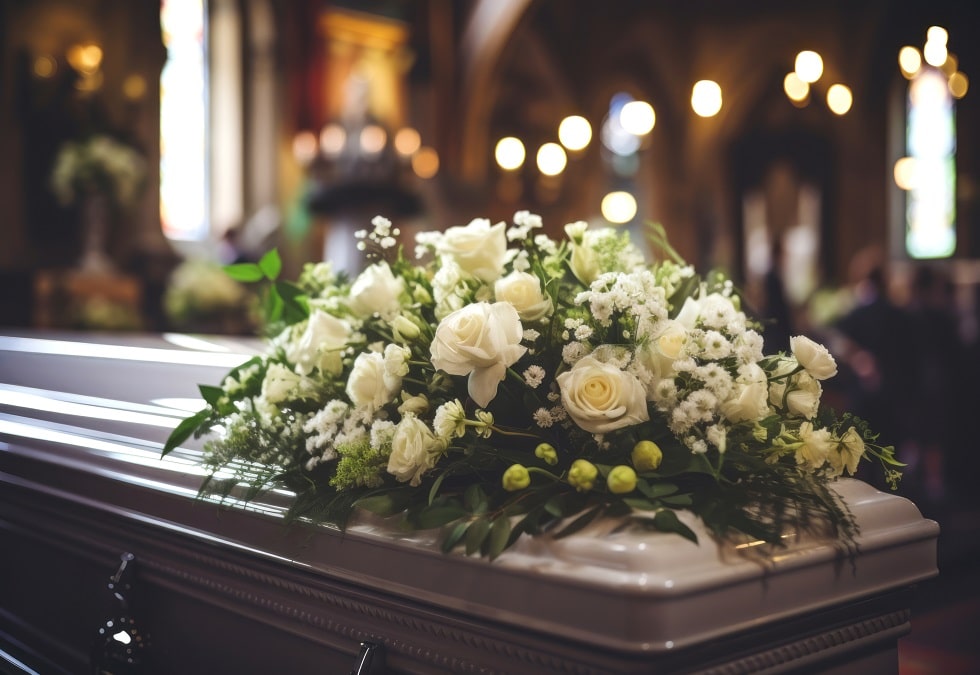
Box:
[51,134,146,208]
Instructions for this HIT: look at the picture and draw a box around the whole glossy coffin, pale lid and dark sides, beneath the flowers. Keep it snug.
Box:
[0,332,938,674]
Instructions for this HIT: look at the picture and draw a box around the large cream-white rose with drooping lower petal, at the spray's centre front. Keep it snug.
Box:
[429,302,527,408]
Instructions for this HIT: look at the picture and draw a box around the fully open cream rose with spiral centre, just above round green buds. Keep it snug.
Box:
[557,356,650,434]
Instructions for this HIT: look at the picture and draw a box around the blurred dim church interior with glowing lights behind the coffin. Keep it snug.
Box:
[0,0,980,675]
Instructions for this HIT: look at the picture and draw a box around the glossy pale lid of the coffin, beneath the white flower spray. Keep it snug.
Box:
[0,334,939,653]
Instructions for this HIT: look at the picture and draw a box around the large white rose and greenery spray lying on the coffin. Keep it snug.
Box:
[164,212,900,559]
